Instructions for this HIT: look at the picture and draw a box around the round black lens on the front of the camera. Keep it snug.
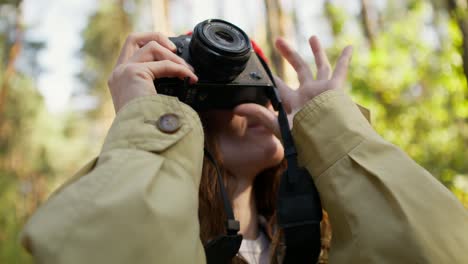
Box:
[190,19,252,82]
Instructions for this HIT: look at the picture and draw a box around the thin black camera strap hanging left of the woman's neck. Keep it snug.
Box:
[204,148,242,264]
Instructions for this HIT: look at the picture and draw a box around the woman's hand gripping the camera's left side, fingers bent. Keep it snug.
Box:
[108,32,198,113]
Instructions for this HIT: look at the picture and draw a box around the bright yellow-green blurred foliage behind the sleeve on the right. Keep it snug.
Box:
[331,1,468,205]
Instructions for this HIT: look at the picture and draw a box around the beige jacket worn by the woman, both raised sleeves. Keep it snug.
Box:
[22,91,468,264]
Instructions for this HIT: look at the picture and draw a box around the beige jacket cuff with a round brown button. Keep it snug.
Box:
[102,94,203,153]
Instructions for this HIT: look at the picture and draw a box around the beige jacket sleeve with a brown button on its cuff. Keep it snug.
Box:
[21,95,205,264]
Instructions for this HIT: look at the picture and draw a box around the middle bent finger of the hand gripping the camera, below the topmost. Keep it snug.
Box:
[127,40,193,71]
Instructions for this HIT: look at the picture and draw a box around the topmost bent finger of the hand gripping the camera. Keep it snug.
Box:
[117,32,176,64]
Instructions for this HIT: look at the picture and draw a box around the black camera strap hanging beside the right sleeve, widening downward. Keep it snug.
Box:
[258,56,322,263]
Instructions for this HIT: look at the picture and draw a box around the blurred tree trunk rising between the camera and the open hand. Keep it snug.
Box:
[264,0,285,79]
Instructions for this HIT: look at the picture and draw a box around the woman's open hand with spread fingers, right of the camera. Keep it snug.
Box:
[234,36,352,137]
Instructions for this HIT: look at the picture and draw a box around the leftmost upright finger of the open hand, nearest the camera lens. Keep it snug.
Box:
[275,38,313,83]
